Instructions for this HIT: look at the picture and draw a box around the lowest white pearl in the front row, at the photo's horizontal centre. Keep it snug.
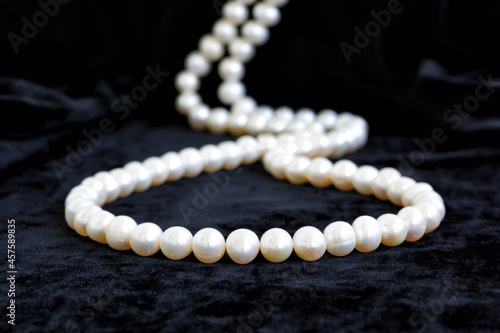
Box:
[226,229,259,264]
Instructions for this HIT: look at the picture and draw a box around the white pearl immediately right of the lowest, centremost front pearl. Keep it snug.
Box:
[260,228,293,262]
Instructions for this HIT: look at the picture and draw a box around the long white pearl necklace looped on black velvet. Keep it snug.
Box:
[65,0,445,264]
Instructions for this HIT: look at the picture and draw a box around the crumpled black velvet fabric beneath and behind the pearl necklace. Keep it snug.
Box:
[0,0,500,332]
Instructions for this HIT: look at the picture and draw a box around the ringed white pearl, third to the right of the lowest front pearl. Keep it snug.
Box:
[323,221,356,257]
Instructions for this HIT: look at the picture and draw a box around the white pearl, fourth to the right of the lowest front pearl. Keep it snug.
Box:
[352,215,382,253]
